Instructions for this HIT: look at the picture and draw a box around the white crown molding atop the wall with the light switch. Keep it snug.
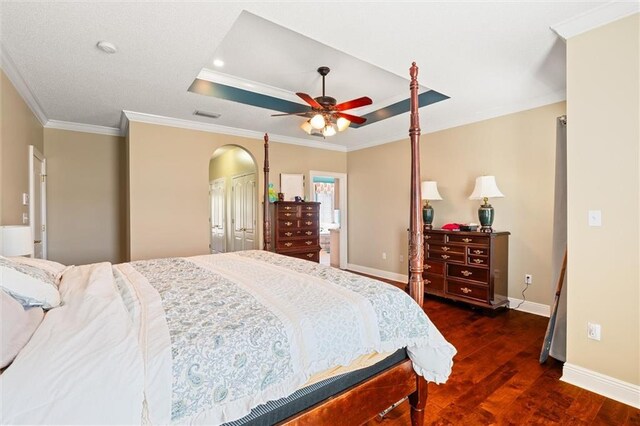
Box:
[551,1,640,40]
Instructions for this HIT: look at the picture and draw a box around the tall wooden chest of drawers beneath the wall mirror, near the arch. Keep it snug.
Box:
[271,201,320,262]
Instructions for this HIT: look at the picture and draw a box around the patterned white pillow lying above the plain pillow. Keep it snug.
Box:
[0,257,60,309]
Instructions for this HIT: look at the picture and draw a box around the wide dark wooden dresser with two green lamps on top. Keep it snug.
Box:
[423,229,509,309]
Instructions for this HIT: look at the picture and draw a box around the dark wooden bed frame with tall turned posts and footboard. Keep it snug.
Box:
[263,62,427,426]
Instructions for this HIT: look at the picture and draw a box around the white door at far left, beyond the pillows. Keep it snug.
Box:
[29,145,47,259]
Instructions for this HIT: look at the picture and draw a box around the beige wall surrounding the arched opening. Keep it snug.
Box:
[128,122,346,260]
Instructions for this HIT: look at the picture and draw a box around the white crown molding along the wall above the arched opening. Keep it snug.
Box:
[122,111,347,152]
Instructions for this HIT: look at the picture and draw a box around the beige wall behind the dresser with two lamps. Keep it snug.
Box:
[348,103,565,305]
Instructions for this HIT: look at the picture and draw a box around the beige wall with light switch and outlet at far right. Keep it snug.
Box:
[567,14,640,386]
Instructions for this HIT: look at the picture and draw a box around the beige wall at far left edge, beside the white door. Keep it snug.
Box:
[0,71,43,225]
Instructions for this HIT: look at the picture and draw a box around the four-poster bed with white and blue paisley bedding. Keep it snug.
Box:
[0,63,455,425]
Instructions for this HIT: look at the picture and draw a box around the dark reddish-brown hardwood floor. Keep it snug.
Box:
[366,296,640,426]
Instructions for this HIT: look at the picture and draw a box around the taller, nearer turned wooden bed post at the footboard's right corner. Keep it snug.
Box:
[409,62,427,426]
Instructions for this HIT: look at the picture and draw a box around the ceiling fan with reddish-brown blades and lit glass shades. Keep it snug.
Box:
[272,67,373,137]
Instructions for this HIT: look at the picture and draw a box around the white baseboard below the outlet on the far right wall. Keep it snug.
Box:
[560,362,640,408]
